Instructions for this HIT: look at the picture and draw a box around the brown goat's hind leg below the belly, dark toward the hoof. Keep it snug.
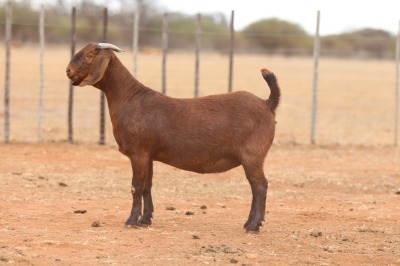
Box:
[243,161,268,232]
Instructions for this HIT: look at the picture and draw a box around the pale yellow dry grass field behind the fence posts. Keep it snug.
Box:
[0,46,395,145]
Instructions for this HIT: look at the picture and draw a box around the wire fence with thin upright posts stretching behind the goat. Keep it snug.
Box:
[0,3,400,146]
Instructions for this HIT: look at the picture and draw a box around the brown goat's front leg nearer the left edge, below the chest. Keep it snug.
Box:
[125,158,149,227]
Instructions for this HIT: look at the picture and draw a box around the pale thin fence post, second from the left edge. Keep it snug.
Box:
[38,5,45,142]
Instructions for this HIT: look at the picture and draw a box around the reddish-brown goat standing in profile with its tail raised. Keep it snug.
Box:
[67,43,280,231]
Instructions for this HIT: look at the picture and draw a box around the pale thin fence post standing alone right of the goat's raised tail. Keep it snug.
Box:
[310,10,320,144]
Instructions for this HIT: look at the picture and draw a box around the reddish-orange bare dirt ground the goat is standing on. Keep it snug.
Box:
[0,143,400,265]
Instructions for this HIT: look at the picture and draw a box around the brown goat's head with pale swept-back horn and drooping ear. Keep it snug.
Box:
[67,43,122,87]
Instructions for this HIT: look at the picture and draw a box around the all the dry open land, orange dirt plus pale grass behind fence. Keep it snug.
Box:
[0,47,400,265]
